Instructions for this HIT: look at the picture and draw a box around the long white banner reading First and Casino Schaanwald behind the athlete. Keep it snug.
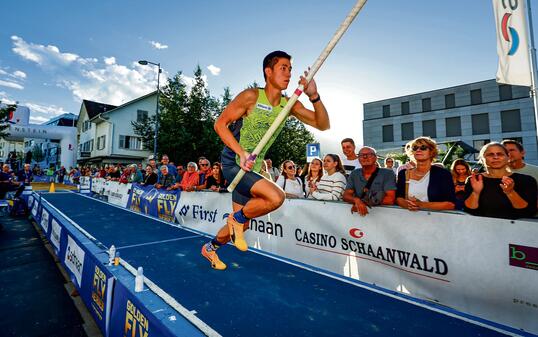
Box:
[175,192,538,333]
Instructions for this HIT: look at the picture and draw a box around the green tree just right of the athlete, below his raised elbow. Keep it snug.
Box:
[265,117,316,167]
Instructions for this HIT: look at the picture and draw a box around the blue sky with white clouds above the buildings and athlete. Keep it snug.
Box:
[0,0,537,152]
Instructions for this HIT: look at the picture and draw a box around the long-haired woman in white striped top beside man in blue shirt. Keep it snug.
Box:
[309,154,346,200]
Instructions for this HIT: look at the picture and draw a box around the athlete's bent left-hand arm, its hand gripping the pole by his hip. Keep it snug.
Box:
[214,89,258,171]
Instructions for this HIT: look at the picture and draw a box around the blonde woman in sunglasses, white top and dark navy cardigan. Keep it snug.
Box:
[396,137,456,211]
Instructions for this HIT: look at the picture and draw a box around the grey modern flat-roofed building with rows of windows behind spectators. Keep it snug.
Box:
[363,80,538,164]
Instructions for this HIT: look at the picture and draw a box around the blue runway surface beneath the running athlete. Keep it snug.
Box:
[42,193,510,337]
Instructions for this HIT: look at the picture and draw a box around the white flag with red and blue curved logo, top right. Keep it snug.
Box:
[492,0,531,86]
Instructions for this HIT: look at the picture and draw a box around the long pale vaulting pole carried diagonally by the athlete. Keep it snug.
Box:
[224,0,366,192]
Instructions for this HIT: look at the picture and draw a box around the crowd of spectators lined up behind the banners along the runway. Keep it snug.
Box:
[0,137,538,219]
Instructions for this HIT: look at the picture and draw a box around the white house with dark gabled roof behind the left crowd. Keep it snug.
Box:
[77,91,157,164]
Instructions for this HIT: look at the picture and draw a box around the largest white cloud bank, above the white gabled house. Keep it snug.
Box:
[11,36,167,105]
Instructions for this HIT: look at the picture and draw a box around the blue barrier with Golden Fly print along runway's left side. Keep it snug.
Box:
[28,192,208,336]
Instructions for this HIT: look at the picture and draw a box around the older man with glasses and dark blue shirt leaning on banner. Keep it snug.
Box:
[344,146,396,216]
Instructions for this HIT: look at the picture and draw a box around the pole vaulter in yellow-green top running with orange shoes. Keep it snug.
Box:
[202,51,330,270]
